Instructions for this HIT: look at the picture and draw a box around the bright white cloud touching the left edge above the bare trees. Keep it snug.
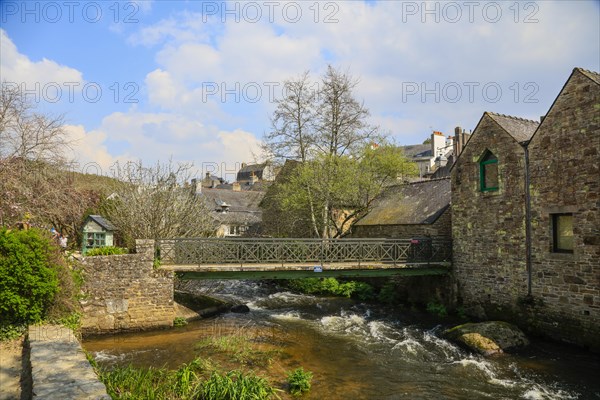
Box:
[0,29,83,90]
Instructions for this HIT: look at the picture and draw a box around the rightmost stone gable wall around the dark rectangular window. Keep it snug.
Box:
[529,70,600,349]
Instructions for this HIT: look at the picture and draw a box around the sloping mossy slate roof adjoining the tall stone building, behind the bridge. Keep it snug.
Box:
[356,178,450,226]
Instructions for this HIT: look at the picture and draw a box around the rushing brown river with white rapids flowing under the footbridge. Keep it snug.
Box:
[84,281,600,400]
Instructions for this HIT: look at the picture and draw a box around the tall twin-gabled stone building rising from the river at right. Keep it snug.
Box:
[452,68,600,348]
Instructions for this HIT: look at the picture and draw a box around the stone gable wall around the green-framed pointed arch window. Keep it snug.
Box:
[452,114,527,306]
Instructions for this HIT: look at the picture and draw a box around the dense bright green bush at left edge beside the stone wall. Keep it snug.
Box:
[0,229,62,325]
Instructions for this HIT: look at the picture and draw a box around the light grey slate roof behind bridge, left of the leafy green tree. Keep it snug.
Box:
[200,189,265,224]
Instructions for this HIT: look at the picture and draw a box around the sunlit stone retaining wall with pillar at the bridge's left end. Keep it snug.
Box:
[81,240,175,334]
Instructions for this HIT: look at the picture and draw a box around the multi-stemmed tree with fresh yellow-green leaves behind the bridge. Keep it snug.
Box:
[279,145,416,238]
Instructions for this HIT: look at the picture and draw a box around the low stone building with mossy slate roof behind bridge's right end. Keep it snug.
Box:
[352,178,451,239]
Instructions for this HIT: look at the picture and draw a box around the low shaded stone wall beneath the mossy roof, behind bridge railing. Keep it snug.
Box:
[352,209,452,239]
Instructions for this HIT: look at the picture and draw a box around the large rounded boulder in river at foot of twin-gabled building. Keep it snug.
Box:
[444,321,529,356]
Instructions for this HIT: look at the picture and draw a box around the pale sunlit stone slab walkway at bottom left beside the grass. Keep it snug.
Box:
[29,325,110,400]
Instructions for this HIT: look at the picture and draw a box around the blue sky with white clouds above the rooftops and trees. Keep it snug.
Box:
[0,0,600,178]
